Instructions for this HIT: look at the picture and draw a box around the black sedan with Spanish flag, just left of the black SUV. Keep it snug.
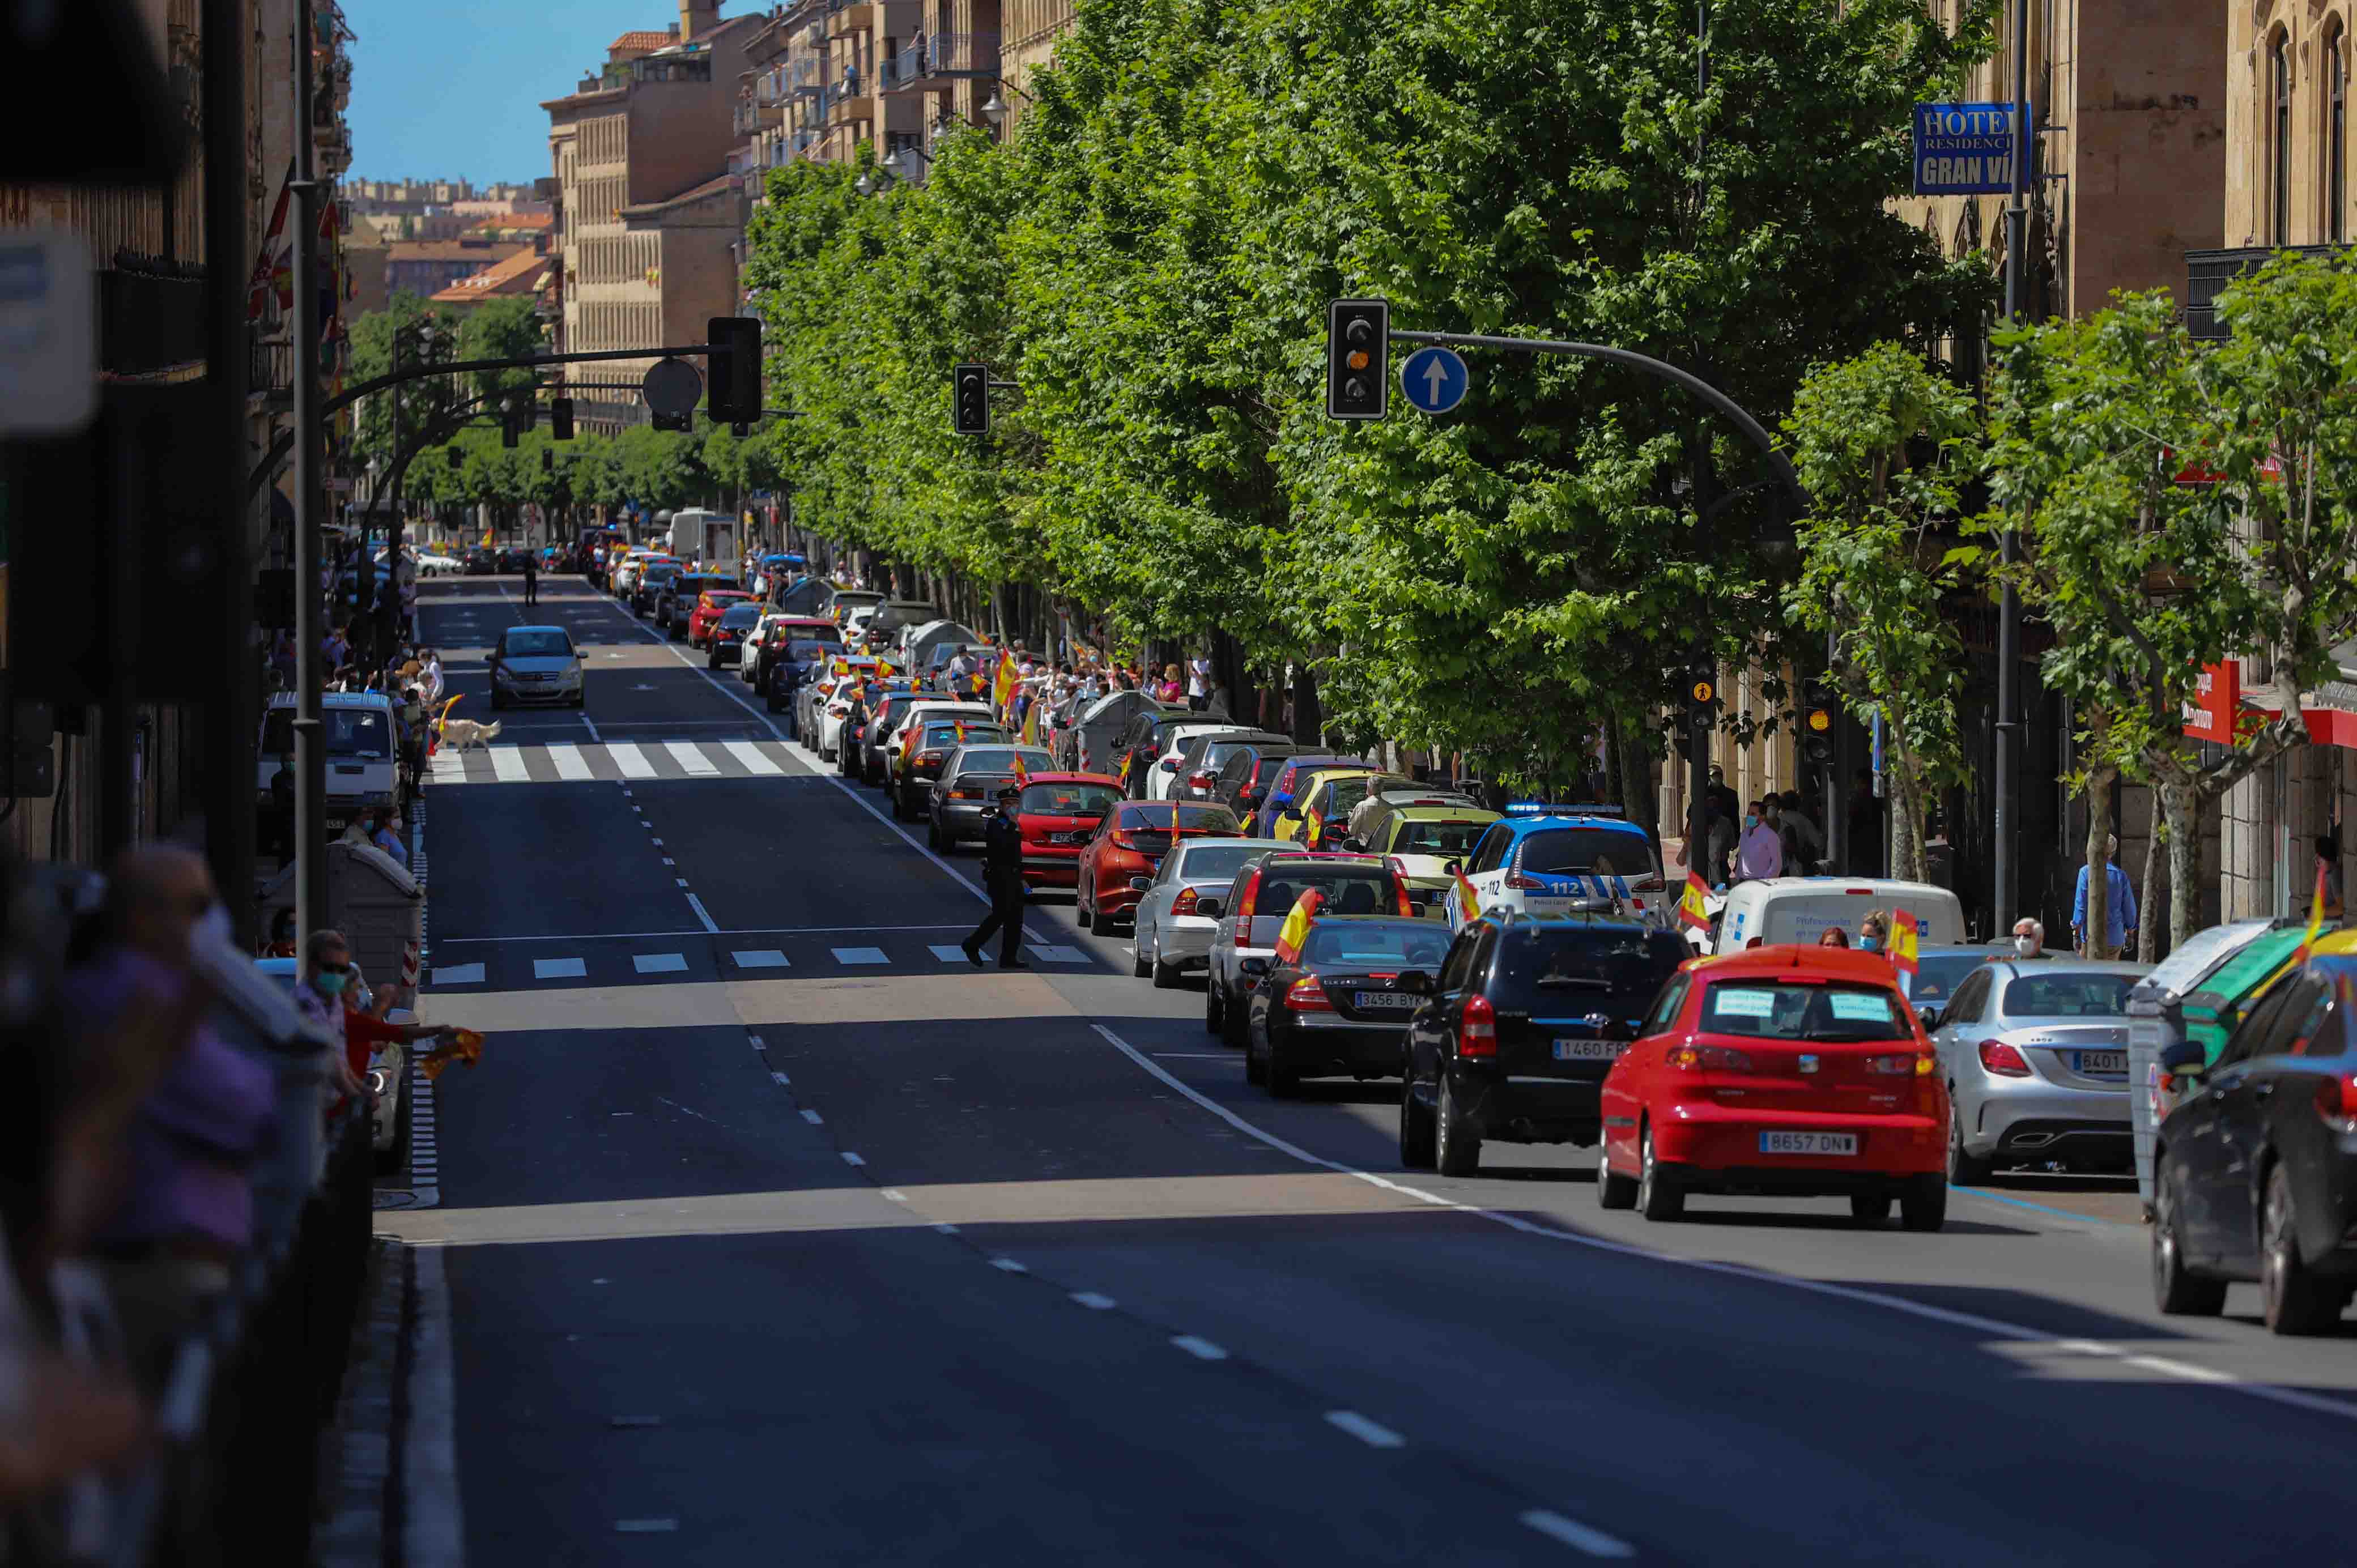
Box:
[1242,915,1449,1099]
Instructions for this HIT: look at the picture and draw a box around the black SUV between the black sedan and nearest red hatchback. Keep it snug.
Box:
[1400,913,1688,1177]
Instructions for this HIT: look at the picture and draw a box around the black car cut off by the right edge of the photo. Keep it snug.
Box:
[2152,936,2357,1335]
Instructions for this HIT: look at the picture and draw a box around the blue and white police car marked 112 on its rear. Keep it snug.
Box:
[1447,802,1676,929]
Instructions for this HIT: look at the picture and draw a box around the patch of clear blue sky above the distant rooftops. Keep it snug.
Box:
[344,0,688,184]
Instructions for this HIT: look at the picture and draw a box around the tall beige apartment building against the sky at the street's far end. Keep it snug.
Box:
[542,0,766,432]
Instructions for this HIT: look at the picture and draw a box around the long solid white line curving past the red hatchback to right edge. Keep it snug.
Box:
[1089,1023,2357,1422]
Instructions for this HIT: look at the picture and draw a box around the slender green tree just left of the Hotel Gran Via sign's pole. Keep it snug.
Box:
[1784,342,1982,880]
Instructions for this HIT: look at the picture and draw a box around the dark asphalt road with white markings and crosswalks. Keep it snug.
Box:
[380,578,2357,1566]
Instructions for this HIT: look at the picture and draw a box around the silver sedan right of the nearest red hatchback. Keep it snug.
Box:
[1930,957,2152,1186]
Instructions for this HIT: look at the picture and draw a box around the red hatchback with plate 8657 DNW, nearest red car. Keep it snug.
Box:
[1596,945,1947,1231]
